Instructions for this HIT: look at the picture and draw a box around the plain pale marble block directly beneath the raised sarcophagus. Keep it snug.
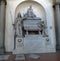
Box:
[24,35,45,53]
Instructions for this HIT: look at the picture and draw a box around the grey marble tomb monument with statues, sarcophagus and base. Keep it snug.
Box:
[13,6,55,54]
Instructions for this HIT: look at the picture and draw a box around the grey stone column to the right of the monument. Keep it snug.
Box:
[55,4,60,49]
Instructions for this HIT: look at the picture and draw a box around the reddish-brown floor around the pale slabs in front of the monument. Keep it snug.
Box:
[0,51,60,61]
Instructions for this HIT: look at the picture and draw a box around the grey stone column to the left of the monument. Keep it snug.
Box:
[0,1,5,54]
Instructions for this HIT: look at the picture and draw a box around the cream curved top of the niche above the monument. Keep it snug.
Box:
[15,0,46,20]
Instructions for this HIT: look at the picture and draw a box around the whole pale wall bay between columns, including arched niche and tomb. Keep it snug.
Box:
[5,0,56,54]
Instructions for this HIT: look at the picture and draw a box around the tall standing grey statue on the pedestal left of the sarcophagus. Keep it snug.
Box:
[14,13,22,37]
